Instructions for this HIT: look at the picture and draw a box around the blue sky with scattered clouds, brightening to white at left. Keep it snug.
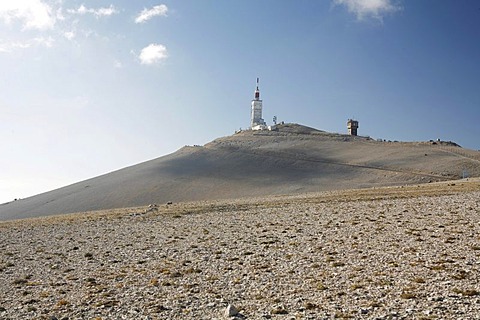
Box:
[0,0,480,203]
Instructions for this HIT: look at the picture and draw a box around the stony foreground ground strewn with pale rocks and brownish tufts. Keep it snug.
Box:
[0,181,480,320]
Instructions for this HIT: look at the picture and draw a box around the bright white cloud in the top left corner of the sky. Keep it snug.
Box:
[0,0,55,30]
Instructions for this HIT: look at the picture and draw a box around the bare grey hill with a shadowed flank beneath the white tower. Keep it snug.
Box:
[0,124,480,220]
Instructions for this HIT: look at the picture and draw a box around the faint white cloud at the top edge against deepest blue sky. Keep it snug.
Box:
[333,0,401,20]
